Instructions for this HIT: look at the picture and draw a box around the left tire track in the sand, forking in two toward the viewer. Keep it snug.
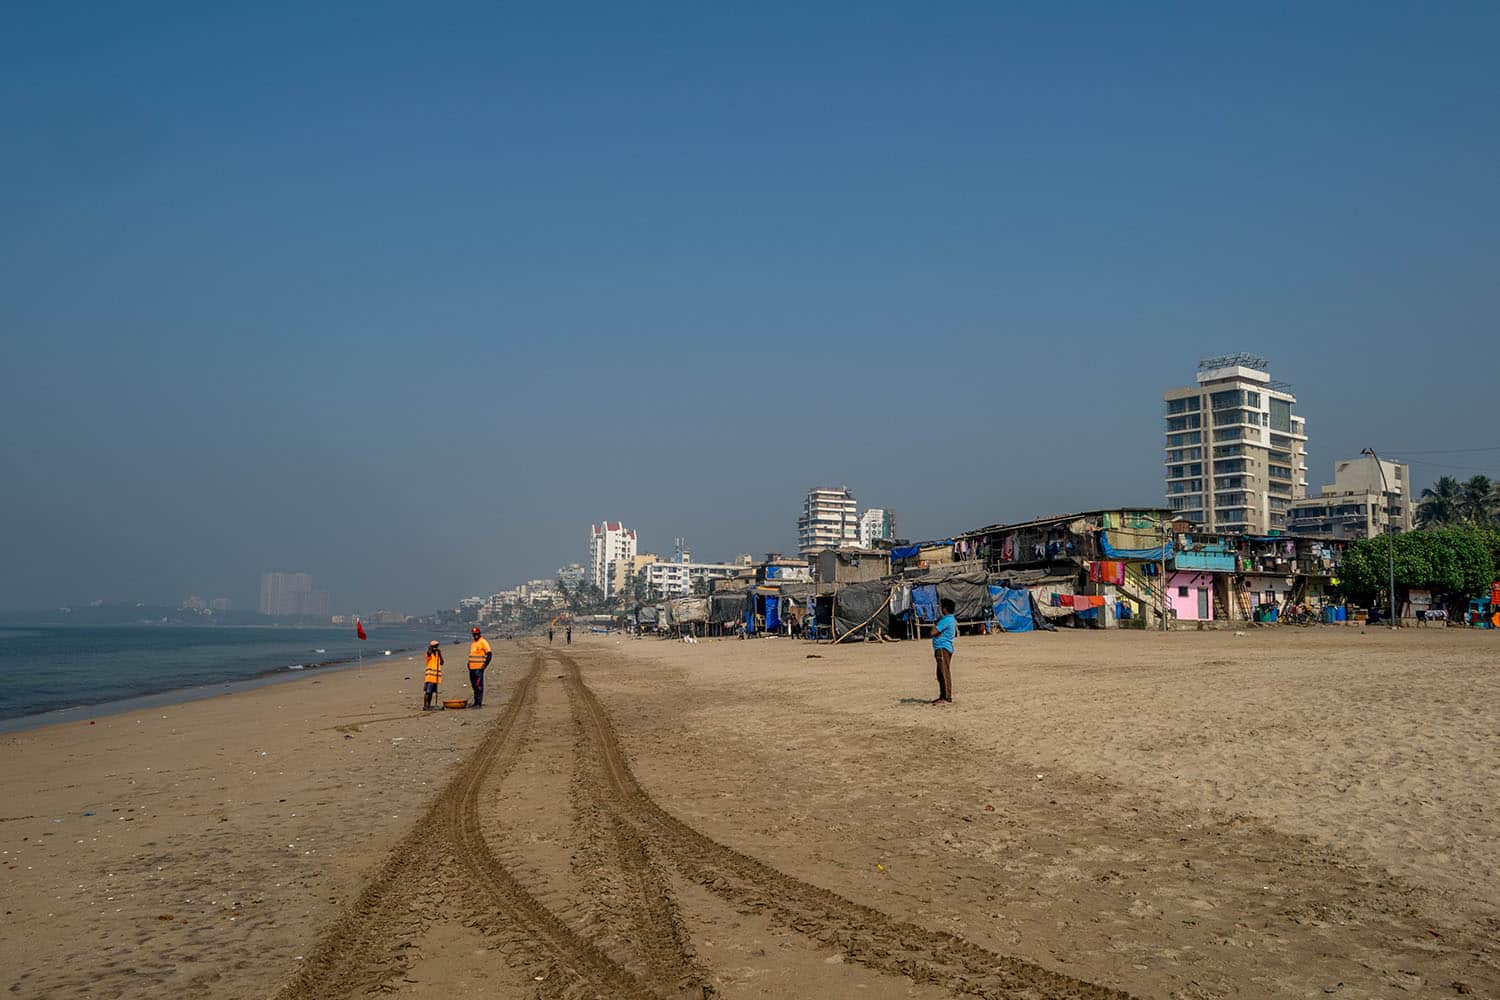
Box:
[275,655,659,1000]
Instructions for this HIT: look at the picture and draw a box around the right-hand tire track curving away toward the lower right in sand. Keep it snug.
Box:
[558,654,1136,1000]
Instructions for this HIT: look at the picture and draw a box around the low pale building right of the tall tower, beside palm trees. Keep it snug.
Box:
[1287,456,1415,538]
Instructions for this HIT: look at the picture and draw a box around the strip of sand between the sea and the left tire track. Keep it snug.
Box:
[0,646,510,1000]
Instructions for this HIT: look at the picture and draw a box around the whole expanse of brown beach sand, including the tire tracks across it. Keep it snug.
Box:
[0,627,1500,1000]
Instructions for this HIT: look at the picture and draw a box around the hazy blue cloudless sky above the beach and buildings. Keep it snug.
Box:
[0,1,1500,613]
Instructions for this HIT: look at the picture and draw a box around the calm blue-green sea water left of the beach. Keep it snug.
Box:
[0,625,438,720]
